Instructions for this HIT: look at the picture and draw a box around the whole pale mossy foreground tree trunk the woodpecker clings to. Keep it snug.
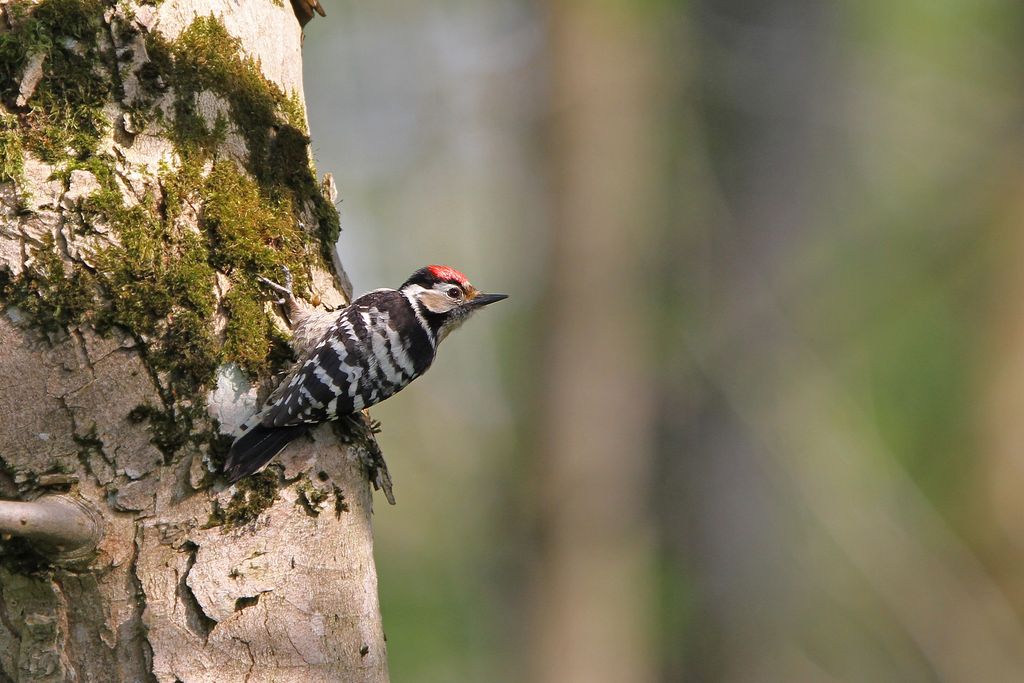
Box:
[0,0,387,683]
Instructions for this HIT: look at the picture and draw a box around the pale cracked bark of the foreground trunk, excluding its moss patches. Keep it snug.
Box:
[0,0,387,683]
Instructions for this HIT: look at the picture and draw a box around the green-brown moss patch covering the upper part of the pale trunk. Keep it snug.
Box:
[0,7,339,479]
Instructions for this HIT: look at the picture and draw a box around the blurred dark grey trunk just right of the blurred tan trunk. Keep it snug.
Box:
[659,0,836,681]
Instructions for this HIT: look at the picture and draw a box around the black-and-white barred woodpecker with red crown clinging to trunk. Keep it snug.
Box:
[224,265,508,482]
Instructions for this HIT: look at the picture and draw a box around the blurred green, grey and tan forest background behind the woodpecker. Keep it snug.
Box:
[304,0,1024,683]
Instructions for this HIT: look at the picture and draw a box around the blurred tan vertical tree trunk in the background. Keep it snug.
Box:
[529,0,663,683]
